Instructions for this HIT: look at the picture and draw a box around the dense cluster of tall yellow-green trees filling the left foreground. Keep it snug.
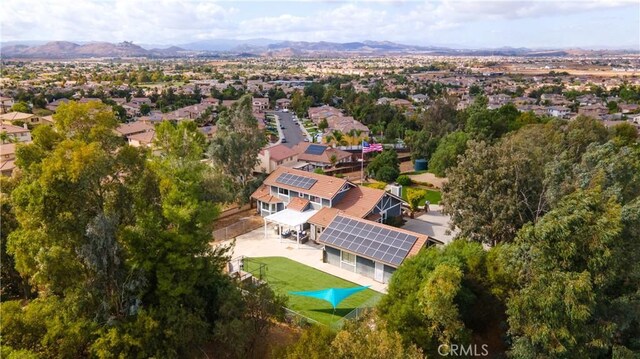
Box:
[0,102,283,358]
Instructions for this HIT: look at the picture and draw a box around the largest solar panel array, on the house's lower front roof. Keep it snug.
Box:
[320,216,418,266]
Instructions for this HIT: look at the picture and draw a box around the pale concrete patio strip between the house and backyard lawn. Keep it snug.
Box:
[214,227,387,293]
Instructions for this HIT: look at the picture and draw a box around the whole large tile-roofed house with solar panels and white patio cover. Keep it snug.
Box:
[251,167,440,283]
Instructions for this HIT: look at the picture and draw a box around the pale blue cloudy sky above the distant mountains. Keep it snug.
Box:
[0,0,640,50]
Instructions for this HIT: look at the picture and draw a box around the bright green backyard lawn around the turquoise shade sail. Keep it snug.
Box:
[244,257,380,325]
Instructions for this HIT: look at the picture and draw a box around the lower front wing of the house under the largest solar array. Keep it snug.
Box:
[318,213,442,283]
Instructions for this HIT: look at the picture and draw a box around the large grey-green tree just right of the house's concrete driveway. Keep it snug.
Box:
[443,124,564,244]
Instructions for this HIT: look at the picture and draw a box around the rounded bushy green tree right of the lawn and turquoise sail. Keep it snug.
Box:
[378,240,504,356]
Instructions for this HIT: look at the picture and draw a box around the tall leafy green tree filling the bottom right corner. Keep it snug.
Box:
[507,187,640,357]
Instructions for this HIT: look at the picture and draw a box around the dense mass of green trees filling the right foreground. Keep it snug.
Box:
[280,117,640,358]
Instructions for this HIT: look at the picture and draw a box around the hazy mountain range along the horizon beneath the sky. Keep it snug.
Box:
[0,39,631,59]
